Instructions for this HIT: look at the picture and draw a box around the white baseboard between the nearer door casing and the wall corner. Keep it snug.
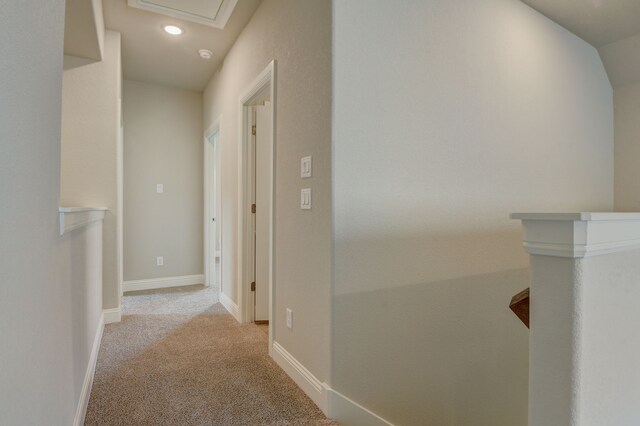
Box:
[272,342,330,416]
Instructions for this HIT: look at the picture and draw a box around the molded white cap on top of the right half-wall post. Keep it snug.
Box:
[510,212,640,258]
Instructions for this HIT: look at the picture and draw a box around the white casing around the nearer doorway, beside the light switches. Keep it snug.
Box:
[238,60,277,354]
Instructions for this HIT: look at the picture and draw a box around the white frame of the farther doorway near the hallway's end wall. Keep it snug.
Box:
[208,116,223,296]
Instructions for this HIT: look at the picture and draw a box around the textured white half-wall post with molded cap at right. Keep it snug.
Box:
[511,213,640,426]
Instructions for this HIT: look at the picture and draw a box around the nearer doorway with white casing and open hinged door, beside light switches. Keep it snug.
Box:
[238,61,276,353]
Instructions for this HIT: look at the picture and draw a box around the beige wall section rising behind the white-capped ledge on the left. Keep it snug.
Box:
[60,30,121,308]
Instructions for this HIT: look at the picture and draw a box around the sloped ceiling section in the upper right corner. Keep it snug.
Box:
[522,0,640,88]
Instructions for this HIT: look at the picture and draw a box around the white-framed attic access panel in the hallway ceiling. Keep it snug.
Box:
[128,0,238,29]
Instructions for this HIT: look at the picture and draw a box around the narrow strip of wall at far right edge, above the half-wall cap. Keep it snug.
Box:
[613,84,640,212]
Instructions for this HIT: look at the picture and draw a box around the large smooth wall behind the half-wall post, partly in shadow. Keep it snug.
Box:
[331,0,613,426]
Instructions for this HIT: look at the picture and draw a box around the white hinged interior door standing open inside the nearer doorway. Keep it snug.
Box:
[254,102,273,321]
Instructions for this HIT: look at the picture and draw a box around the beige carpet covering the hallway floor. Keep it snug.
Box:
[85,286,337,426]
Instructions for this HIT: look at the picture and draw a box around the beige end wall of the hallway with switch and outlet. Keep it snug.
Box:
[123,80,204,281]
